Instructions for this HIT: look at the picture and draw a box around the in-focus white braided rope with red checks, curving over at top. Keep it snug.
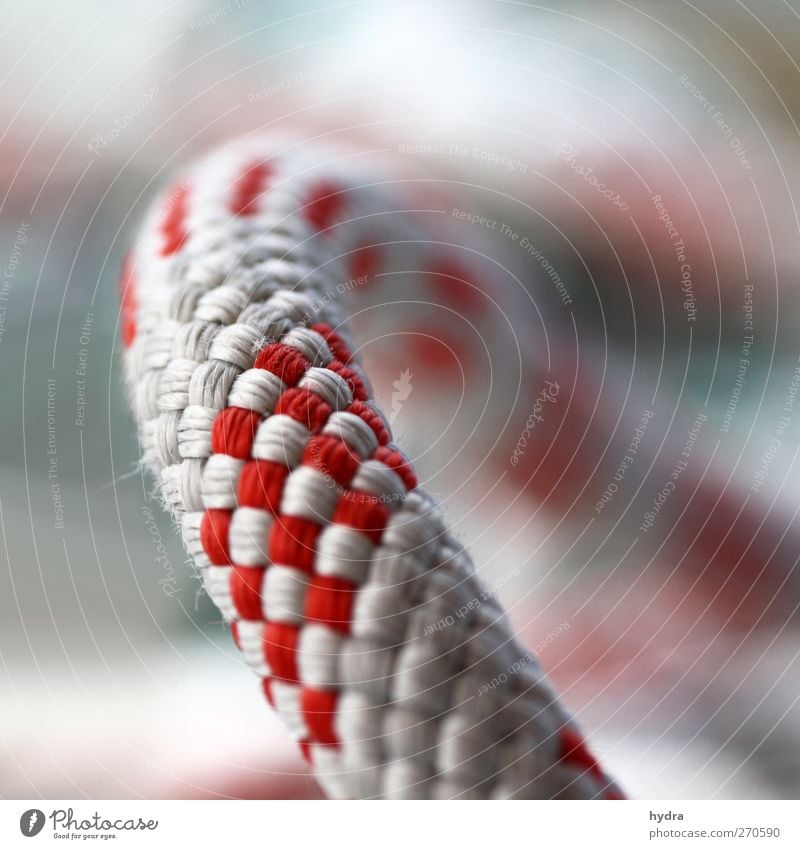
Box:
[122,139,621,798]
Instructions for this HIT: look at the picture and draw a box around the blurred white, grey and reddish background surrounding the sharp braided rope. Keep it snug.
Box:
[0,0,800,798]
